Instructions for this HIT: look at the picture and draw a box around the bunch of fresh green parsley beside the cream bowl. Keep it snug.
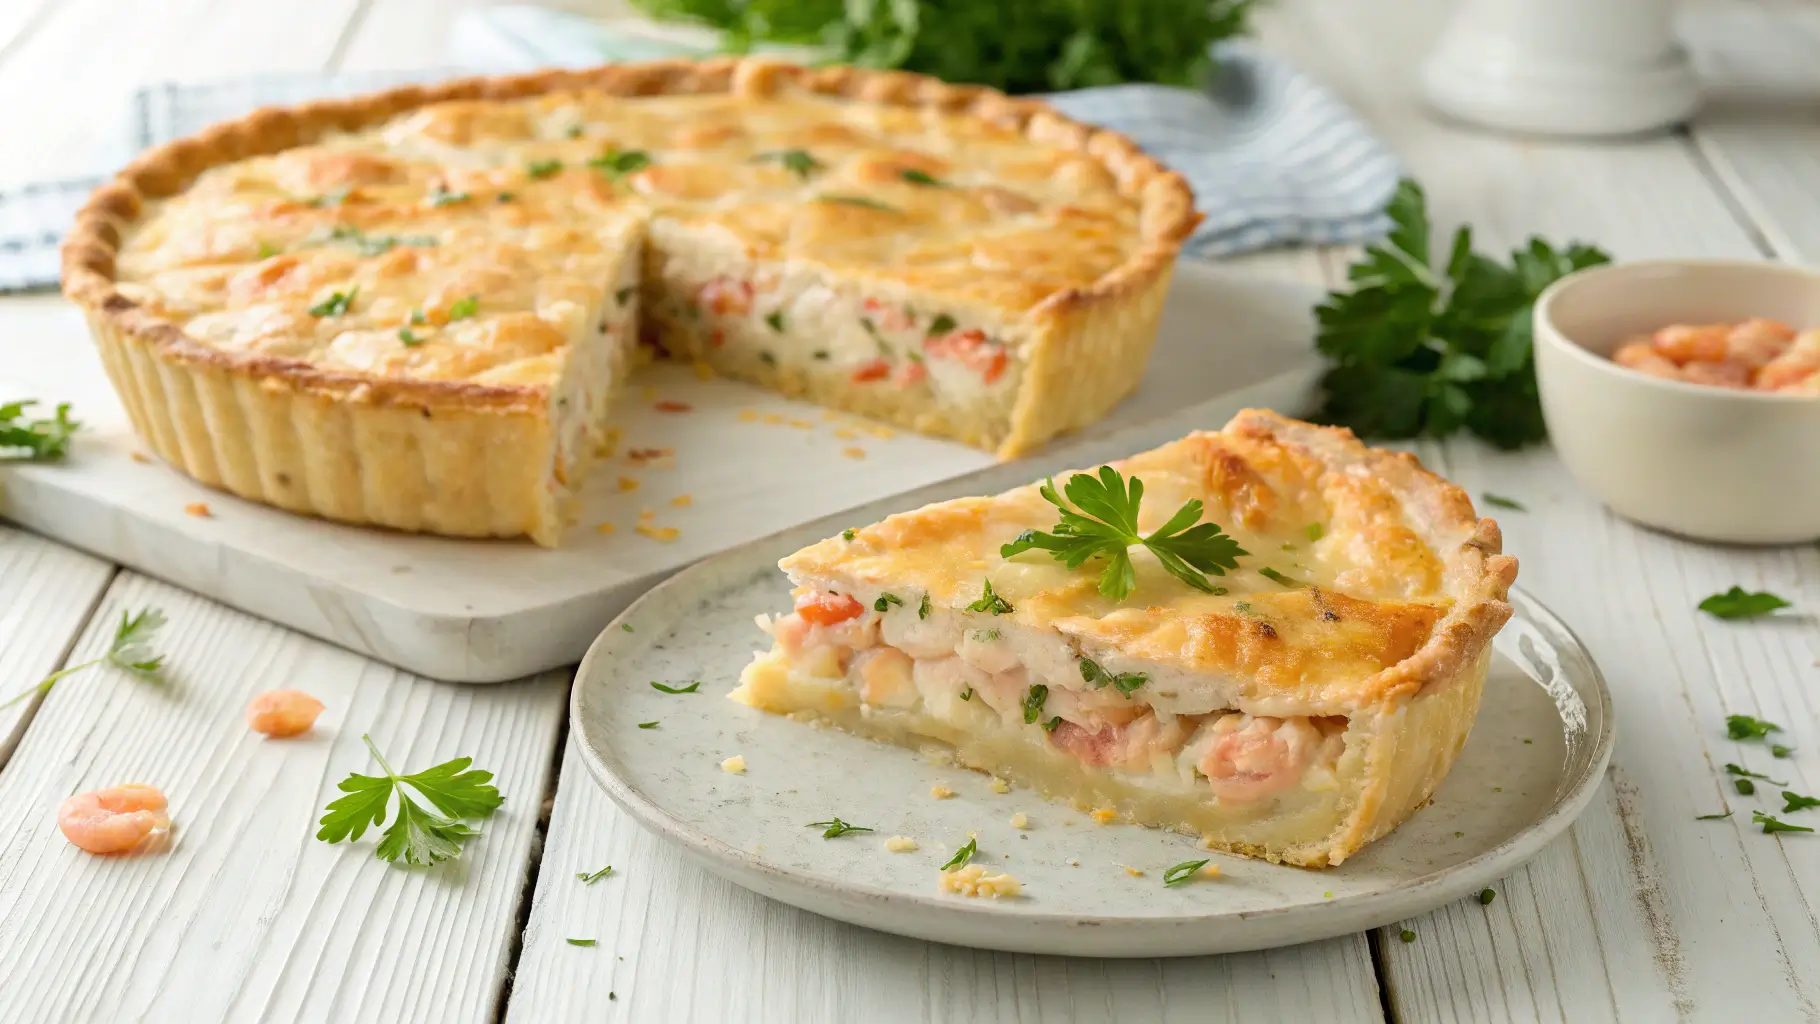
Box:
[1314,178,1611,447]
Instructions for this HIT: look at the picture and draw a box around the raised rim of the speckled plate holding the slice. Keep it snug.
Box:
[570,413,1616,957]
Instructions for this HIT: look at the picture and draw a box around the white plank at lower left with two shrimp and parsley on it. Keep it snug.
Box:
[0,575,566,1022]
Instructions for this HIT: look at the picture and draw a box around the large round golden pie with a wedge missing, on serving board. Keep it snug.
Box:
[64,58,1198,544]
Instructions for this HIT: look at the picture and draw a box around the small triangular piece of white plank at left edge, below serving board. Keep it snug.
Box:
[0,526,113,768]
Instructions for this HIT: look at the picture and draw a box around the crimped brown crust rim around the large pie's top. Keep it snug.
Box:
[62,58,1199,416]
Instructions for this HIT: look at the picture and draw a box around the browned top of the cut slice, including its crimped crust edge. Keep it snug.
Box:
[781,409,1516,713]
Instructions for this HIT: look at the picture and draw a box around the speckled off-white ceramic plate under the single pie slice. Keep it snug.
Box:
[571,476,1613,957]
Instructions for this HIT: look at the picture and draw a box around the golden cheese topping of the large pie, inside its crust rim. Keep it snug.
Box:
[118,93,1139,386]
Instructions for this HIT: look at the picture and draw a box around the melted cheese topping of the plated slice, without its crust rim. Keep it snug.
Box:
[781,413,1465,715]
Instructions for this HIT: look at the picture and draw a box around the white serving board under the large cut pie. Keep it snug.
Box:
[0,264,1316,682]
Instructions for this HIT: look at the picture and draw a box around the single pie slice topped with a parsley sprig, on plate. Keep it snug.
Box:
[732,411,1516,866]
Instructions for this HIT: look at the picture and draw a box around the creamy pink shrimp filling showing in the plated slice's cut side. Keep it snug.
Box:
[759,591,1347,804]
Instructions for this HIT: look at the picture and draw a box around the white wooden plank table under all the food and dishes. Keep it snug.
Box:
[0,0,1820,1022]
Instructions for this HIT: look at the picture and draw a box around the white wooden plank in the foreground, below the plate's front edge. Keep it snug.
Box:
[506,738,1383,1024]
